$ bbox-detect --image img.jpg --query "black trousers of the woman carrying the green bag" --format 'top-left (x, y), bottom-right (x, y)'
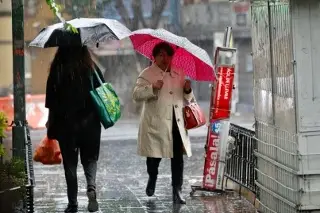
top-left (57, 113), bottom-right (101, 205)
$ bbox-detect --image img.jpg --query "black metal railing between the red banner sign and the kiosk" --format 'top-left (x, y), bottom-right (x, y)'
top-left (225, 124), bottom-right (257, 193)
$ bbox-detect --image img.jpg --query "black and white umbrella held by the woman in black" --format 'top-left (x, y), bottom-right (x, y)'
top-left (29, 18), bottom-right (131, 48)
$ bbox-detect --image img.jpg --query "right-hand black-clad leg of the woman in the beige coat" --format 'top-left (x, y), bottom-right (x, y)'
top-left (171, 117), bottom-right (185, 204)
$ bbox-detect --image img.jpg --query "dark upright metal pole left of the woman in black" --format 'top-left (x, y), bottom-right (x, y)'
top-left (12, 0), bottom-right (26, 159)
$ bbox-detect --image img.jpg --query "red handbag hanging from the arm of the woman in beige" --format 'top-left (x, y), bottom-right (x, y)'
top-left (183, 99), bottom-right (206, 130)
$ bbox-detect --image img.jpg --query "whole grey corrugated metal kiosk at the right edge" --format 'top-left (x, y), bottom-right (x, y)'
top-left (251, 0), bottom-right (320, 213)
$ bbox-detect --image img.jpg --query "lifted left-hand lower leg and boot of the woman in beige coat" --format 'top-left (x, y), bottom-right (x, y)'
top-left (146, 157), bottom-right (161, 197)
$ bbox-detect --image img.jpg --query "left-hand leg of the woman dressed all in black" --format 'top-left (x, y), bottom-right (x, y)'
top-left (59, 138), bottom-right (79, 212)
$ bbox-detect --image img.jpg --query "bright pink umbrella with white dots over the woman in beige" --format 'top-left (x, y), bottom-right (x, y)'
top-left (130, 29), bottom-right (215, 81)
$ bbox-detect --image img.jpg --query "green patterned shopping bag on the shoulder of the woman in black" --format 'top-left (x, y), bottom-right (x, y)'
top-left (90, 70), bottom-right (121, 129)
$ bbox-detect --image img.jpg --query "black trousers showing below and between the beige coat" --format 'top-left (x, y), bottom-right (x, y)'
top-left (147, 113), bottom-right (184, 189)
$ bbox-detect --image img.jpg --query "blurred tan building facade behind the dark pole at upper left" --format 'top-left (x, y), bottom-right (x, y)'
top-left (0, 0), bottom-right (59, 96)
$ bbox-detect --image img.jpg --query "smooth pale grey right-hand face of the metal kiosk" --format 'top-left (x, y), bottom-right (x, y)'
top-left (291, 0), bottom-right (320, 212)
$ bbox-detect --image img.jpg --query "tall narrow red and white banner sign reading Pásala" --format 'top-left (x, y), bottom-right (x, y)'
top-left (203, 65), bottom-right (234, 191)
